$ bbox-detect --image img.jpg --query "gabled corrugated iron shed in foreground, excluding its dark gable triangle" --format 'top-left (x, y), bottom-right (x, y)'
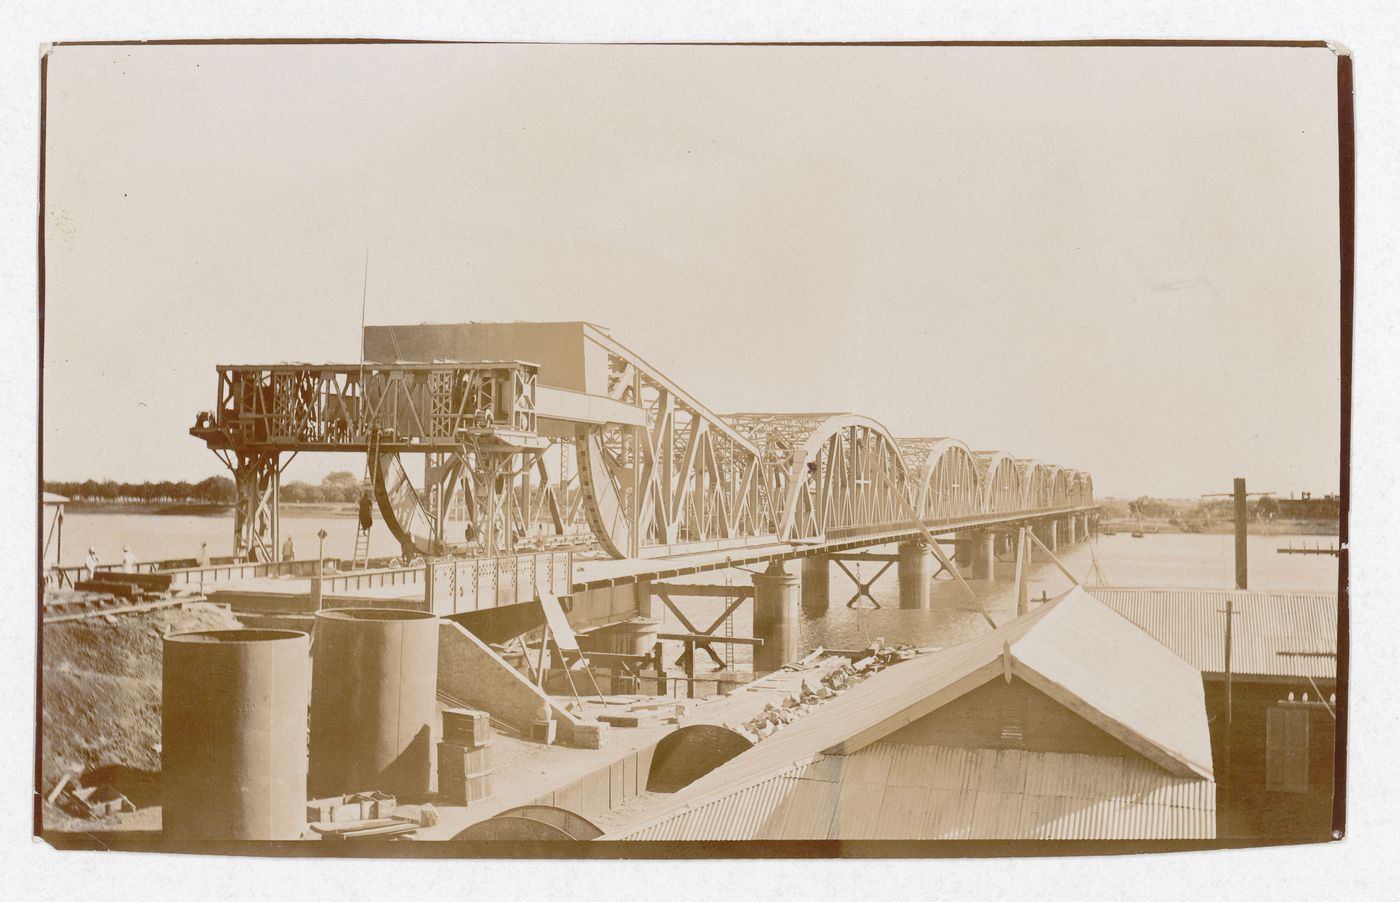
top-left (609, 590), bottom-right (1215, 839)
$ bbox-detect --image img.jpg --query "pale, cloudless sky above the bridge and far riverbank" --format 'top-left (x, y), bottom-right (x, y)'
top-left (42, 45), bottom-right (1340, 497)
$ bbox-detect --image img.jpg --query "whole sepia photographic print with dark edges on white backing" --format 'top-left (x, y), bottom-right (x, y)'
top-left (28, 35), bottom-right (1354, 859)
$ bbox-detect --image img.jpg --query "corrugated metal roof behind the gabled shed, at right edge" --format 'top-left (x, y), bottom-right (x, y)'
top-left (1088, 585), bottom-right (1337, 679)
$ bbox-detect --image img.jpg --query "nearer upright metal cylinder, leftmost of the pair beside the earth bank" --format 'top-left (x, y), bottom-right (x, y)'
top-left (161, 629), bottom-right (311, 842)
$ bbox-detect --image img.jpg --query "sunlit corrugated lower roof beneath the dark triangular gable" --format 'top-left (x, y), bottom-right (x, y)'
top-left (605, 742), bottom-right (1215, 840)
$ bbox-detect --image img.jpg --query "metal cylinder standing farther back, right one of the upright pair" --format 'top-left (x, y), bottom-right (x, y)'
top-left (311, 608), bottom-right (438, 798)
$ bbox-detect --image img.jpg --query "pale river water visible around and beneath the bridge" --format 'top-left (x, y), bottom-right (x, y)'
top-left (54, 513), bottom-right (1337, 669)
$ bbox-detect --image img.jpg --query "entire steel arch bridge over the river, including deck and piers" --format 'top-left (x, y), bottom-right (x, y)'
top-left (190, 322), bottom-right (1096, 672)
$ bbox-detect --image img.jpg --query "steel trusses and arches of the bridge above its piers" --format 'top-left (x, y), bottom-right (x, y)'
top-left (190, 322), bottom-right (1095, 560)
